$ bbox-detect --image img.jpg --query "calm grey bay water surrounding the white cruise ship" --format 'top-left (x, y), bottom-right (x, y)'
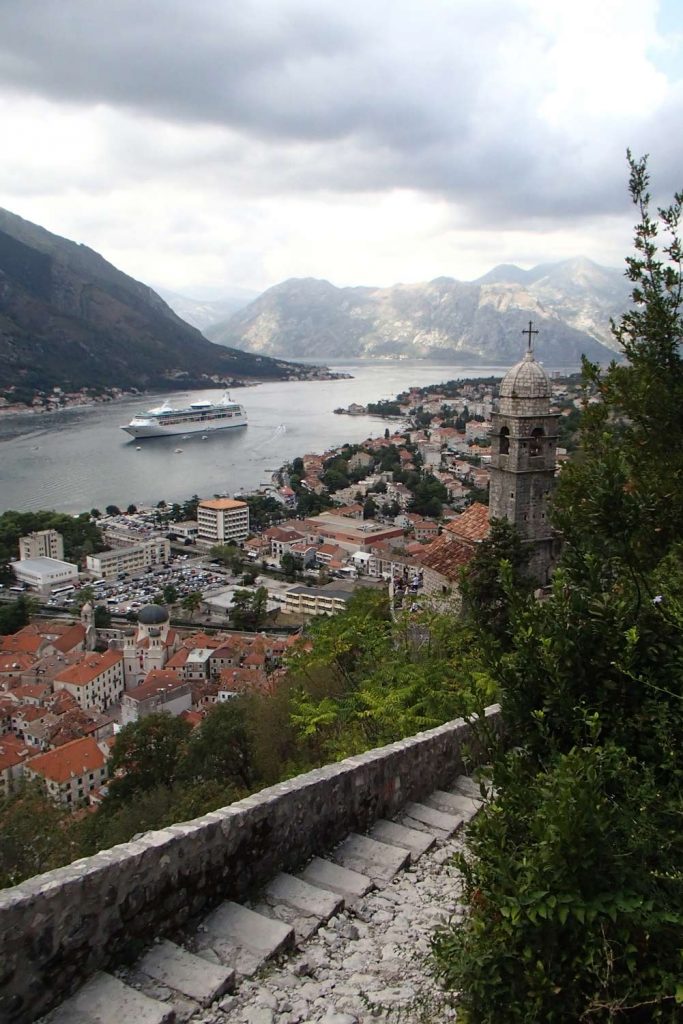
top-left (0, 361), bottom-right (518, 512)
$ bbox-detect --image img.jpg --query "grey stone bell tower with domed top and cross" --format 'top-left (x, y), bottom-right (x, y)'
top-left (488, 321), bottom-right (558, 585)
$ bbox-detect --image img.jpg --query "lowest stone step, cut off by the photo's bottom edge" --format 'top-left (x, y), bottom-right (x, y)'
top-left (43, 971), bottom-right (175, 1024)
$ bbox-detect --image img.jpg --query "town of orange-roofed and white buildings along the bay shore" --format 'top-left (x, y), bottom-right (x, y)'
top-left (0, 364), bottom-right (582, 807)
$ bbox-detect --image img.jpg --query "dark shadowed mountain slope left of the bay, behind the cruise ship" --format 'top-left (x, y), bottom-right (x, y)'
top-left (0, 209), bottom-right (300, 395)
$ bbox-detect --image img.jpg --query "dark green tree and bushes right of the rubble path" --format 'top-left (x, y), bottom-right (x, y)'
top-left (435, 155), bottom-right (683, 1024)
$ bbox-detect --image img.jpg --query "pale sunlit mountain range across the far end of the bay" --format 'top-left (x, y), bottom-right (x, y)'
top-left (206, 259), bottom-right (628, 367)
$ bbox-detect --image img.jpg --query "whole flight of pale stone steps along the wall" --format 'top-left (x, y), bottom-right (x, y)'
top-left (43, 776), bottom-right (481, 1024)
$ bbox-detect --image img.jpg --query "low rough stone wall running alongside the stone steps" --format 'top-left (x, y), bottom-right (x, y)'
top-left (0, 706), bottom-right (501, 1024)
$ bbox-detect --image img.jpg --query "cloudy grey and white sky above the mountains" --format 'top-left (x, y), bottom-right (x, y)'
top-left (0, 0), bottom-right (683, 298)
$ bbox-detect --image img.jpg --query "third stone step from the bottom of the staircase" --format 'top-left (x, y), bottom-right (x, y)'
top-left (195, 901), bottom-right (294, 975)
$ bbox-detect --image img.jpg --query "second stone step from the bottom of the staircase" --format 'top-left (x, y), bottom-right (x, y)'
top-left (135, 941), bottom-right (234, 1007)
